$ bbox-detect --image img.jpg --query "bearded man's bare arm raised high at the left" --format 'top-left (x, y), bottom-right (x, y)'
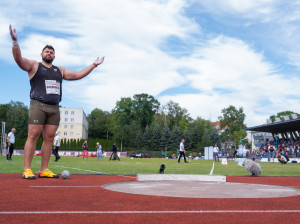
top-left (9, 25), bottom-right (35, 72)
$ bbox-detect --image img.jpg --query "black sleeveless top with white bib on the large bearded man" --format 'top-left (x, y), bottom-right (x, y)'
top-left (30, 63), bottom-right (62, 105)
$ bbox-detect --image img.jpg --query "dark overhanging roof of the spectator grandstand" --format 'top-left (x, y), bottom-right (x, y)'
top-left (245, 118), bottom-right (300, 133)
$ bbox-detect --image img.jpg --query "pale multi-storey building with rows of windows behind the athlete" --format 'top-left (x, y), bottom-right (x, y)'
top-left (57, 108), bottom-right (89, 139)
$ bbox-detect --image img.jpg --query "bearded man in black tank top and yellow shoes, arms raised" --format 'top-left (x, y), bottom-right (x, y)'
top-left (9, 25), bottom-right (104, 179)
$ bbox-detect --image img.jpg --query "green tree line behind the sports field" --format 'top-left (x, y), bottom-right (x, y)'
top-left (0, 93), bottom-right (255, 152)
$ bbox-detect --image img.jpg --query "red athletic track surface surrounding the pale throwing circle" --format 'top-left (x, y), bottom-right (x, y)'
top-left (0, 174), bottom-right (300, 224)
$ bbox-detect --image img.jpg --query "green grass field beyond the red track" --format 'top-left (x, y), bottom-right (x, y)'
top-left (0, 156), bottom-right (300, 176)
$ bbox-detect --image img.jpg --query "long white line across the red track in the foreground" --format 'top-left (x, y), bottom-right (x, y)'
top-left (0, 210), bottom-right (300, 215)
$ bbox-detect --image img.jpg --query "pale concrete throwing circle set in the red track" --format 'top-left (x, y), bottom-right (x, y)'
top-left (102, 181), bottom-right (300, 198)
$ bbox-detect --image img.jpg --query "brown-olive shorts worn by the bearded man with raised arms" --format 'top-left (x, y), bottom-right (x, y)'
top-left (28, 100), bottom-right (60, 126)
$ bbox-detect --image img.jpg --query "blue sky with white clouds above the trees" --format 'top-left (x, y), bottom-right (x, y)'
top-left (0, 0), bottom-right (300, 126)
